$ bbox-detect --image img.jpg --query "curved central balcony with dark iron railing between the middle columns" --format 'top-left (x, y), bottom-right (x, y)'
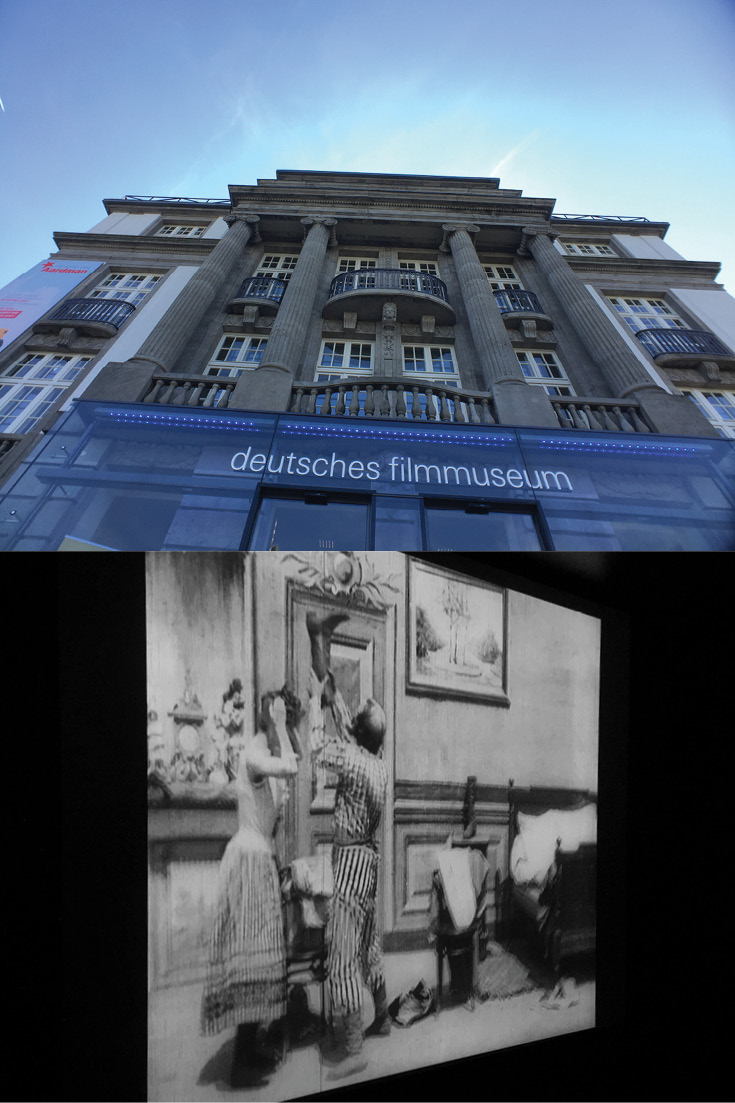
top-left (322, 268), bottom-right (456, 325)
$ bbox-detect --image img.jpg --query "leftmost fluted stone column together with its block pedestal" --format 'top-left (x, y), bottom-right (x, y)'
top-left (84, 214), bottom-right (260, 401)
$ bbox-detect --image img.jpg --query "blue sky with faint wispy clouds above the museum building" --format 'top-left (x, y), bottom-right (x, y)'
top-left (0, 0), bottom-right (735, 293)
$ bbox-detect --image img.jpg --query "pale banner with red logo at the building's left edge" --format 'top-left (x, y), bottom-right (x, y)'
top-left (0, 259), bottom-right (102, 349)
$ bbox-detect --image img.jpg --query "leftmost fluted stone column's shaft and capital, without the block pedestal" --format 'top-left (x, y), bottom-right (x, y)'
top-left (121, 214), bottom-right (259, 372)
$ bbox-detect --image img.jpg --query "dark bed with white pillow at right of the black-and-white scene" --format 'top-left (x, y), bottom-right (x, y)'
top-left (497, 780), bottom-right (597, 974)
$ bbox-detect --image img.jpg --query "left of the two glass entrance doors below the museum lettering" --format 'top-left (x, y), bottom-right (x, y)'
top-left (248, 493), bottom-right (371, 552)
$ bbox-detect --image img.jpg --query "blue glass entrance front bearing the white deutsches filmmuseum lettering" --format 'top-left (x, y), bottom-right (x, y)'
top-left (0, 400), bottom-right (735, 550)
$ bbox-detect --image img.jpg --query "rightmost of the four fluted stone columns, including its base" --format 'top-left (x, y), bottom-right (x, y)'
top-left (518, 226), bottom-right (716, 437)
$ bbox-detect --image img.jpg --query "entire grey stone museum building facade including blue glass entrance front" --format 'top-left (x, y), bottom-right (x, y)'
top-left (0, 171), bottom-right (735, 550)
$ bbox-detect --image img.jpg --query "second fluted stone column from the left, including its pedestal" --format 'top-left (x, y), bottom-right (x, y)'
top-left (230, 218), bottom-right (337, 410)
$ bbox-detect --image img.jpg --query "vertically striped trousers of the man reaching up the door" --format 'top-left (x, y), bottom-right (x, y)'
top-left (327, 846), bottom-right (385, 1013)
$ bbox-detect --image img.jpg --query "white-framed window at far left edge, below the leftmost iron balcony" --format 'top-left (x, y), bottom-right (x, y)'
top-left (0, 353), bottom-right (92, 433)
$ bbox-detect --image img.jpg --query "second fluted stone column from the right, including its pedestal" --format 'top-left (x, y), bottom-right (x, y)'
top-left (440, 225), bottom-right (558, 427)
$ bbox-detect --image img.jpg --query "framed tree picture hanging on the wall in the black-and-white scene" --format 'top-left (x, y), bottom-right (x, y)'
top-left (406, 559), bottom-right (510, 706)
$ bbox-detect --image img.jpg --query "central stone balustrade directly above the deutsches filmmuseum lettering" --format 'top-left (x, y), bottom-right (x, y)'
top-left (289, 378), bottom-right (498, 425)
